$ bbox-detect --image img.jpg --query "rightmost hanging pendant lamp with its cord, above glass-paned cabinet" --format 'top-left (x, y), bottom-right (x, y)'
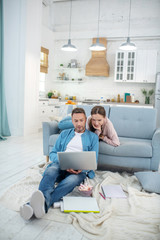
top-left (119, 0), bottom-right (136, 51)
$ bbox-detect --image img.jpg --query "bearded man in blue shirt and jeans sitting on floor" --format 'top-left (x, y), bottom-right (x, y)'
top-left (20, 108), bottom-right (99, 220)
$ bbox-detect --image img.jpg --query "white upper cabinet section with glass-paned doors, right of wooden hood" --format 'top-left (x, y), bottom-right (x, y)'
top-left (115, 51), bottom-right (136, 82)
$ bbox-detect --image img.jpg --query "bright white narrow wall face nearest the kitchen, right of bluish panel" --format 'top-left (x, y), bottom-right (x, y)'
top-left (24, 0), bottom-right (42, 135)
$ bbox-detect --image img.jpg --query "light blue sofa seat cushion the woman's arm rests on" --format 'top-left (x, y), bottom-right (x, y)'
top-left (99, 137), bottom-right (152, 158)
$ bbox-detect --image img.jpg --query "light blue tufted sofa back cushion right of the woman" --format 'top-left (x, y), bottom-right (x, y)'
top-left (109, 106), bottom-right (156, 139)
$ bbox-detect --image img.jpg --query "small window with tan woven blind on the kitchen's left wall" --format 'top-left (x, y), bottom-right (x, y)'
top-left (40, 47), bottom-right (49, 73)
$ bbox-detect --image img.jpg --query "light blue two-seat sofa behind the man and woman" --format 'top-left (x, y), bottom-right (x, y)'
top-left (43, 105), bottom-right (160, 171)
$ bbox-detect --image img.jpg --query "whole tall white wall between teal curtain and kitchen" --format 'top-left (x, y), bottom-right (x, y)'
top-left (3, 0), bottom-right (42, 135)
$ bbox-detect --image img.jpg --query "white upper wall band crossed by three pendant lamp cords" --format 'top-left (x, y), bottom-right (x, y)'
top-left (43, 0), bottom-right (160, 39)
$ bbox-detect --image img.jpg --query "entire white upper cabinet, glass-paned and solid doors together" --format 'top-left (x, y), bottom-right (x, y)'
top-left (115, 50), bottom-right (157, 83)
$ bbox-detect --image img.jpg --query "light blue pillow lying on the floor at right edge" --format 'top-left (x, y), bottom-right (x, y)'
top-left (134, 172), bottom-right (160, 193)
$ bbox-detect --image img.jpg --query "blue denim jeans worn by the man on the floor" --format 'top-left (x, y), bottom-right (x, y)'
top-left (39, 163), bottom-right (86, 212)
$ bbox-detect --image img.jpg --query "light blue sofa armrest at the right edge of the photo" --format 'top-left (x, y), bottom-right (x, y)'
top-left (151, 128), bottom-right (160, 171)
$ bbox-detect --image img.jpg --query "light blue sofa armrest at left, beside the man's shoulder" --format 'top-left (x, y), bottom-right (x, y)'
top-left (42, 121), bottom-right (59, 156)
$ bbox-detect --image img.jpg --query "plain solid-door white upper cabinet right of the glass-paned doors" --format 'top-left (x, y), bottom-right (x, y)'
top-left (136, 50), bottom-right (157, 83)
